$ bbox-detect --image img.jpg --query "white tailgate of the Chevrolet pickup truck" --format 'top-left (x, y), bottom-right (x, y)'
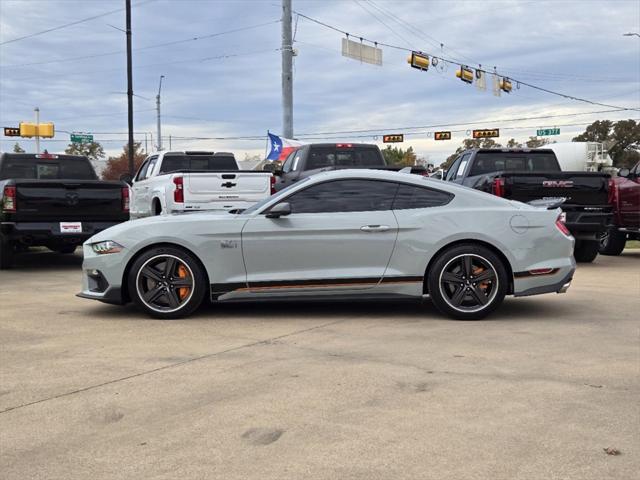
top-left (184, 171), bottom-right (271, 204)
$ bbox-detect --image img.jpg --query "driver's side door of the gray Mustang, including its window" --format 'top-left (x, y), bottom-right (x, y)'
top-left (242, 179), bottom-right (398, 292)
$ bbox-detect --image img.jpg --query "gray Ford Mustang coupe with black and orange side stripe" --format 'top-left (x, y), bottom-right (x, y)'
top-left (79, 170), bottom-right (575, 319)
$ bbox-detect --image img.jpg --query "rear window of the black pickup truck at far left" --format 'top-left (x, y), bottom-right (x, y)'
top-left (0, 155), bottom-right (96, 180)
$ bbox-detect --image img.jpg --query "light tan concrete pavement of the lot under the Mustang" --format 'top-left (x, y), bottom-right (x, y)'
top-left (0, 250), bottom-right (640, 480)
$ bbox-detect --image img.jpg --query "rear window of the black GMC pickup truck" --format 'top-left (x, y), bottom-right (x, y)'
top-left (469, 151), bottom-right (560, 176)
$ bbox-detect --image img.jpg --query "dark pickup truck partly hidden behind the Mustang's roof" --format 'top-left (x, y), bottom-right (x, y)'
top-left (273, 143), bottom-right (427, 191)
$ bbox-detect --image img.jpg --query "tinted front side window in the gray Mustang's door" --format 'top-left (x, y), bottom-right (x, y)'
top-left (284, 180), bottom-right (398, 214)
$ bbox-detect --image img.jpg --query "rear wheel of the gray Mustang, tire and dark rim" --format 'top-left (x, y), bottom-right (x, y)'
top-left (427, 243), bottom-right (509, 320)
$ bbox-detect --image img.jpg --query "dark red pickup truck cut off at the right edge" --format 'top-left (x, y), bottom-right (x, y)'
top-left (600, 162), bottom-right (640, 255)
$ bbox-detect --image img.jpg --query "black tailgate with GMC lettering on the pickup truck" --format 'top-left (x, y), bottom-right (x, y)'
top-left (500, 172), bottom-right (609, 205)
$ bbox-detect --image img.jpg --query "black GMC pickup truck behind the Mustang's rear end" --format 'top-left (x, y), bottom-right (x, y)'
top-left (445, 149), bottom-right (612, 262)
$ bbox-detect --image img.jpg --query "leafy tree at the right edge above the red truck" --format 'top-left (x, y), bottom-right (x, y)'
top-left (573, 119), bottom-right (640, 167)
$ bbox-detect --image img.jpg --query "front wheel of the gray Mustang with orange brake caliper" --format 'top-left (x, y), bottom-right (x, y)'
top-left (127, 247), bottom-right (209, 319)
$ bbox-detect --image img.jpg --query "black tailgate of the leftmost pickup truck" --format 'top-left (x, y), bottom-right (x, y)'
top-left (15, 180), bottom-right (128, 222)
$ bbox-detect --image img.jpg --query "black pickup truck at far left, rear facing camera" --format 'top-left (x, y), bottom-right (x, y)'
top-left (0, 153), bottom-right (129, 269)
